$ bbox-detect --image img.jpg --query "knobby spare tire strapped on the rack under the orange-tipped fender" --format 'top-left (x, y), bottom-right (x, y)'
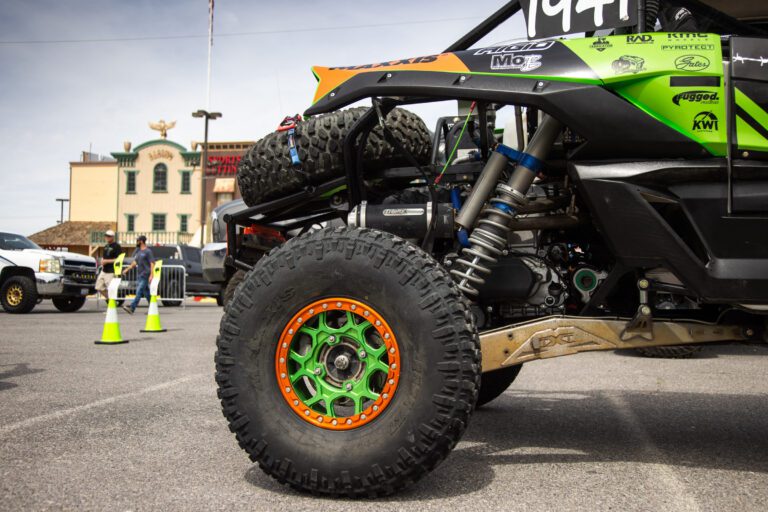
top-left (237, 107), bottom-right (432, 206)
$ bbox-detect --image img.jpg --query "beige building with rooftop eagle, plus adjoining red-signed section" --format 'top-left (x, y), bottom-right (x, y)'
top-left (61, 121), bottom-right (253, 252)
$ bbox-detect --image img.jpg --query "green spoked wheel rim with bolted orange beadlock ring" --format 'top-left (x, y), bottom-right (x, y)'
top-left (275, 297), bottom-right (400, 430)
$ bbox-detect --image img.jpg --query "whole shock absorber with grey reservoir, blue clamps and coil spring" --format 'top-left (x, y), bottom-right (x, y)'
top-left (451, 115), bottom-right (562, 296)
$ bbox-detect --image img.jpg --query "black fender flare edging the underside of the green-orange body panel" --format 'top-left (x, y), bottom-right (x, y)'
top-left (307, 71), bottom-right (704, 159)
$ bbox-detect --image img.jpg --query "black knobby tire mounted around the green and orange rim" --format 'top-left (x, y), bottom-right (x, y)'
top-left (215, 228), bottom-right (480, 497)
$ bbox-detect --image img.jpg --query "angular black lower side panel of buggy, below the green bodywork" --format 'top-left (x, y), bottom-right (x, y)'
top-left (570, 159), bottom-right (768, 304)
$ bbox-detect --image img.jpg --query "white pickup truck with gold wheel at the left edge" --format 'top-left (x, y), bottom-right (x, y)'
top-left (0, 233), bottom-right (96, 313)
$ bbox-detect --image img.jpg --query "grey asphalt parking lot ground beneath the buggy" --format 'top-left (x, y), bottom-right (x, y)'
top-left (0, 303), bottom-right (768, 511)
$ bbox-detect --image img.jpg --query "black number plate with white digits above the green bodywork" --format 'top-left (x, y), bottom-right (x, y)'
top-left (520, 0), bottom-right (637, 39)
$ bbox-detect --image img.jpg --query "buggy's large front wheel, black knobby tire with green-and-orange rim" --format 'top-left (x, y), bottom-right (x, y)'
top-left (215, 228), bottom-right (480, 497)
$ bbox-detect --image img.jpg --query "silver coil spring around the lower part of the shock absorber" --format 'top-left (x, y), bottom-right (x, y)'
top-left (451, 183), bottom-right (524, 296)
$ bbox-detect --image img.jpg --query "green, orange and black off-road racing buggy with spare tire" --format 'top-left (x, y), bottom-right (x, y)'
top-left (216, 0), bottom-right (768, 496)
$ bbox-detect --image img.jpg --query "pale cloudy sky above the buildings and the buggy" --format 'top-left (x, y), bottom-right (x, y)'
top-left (0, 0), bottom-right (523, 235)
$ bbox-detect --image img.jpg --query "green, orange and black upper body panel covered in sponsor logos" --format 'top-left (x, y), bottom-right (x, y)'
top-left (313, 32), bottom-right (768, 157)
